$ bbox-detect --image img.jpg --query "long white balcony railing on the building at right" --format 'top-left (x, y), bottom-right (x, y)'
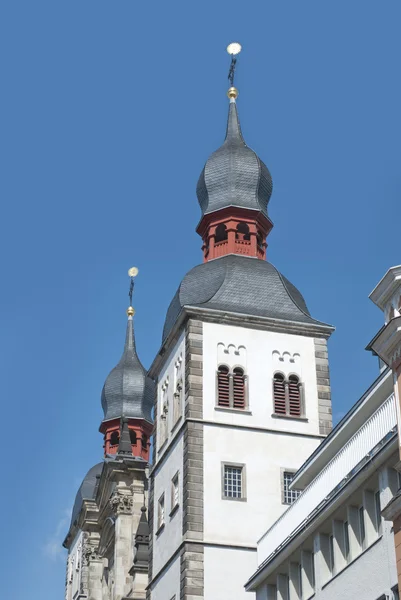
top-left (258, 394), bottom-right (397, 565)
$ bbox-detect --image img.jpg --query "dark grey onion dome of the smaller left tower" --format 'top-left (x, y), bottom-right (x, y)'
top-left (102, 317), bottom-right (154, 423)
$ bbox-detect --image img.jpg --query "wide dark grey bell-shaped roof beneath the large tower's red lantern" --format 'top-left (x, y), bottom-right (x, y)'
top-left (163, 254), bottom-right (325, 340)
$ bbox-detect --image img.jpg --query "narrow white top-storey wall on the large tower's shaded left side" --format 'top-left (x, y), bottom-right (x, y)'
top-left (157, 331), bottom-right (185, 458)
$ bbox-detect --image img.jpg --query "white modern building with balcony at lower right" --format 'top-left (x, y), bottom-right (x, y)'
top-left (247, 372), bottom-right (399, 600)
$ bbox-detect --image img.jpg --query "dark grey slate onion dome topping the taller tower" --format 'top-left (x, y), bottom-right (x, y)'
top-left (196, 100), bottom-right (273, 216)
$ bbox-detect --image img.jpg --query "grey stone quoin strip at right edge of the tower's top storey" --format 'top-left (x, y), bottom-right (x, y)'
top-left (314, 338), bottom-right (333, 435)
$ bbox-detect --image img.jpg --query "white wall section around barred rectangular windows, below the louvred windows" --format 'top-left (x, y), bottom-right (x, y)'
top-left (204, 425), bottom-right (320, 548)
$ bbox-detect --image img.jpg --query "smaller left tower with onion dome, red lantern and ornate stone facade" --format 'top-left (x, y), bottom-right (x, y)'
top-left (63, 278), bottom-right (154, 600)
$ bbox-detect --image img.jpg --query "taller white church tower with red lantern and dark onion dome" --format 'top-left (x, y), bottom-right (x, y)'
top-left (148, 47), bottom-right (333, 600)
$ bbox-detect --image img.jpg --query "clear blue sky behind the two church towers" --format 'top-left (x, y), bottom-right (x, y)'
top-left (0, 0), bottom-right (401, 600)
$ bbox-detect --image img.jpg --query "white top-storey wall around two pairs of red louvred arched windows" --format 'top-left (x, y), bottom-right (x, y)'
top-left (203, 323), bottom-right (319, 434)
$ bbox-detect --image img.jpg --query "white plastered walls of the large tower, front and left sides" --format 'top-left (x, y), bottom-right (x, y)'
top-left (150, 321), bottom-right (325, 600)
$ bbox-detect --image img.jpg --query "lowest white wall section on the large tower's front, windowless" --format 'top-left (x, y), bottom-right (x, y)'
top-left (204, 547), bottom-right (257, 600)
